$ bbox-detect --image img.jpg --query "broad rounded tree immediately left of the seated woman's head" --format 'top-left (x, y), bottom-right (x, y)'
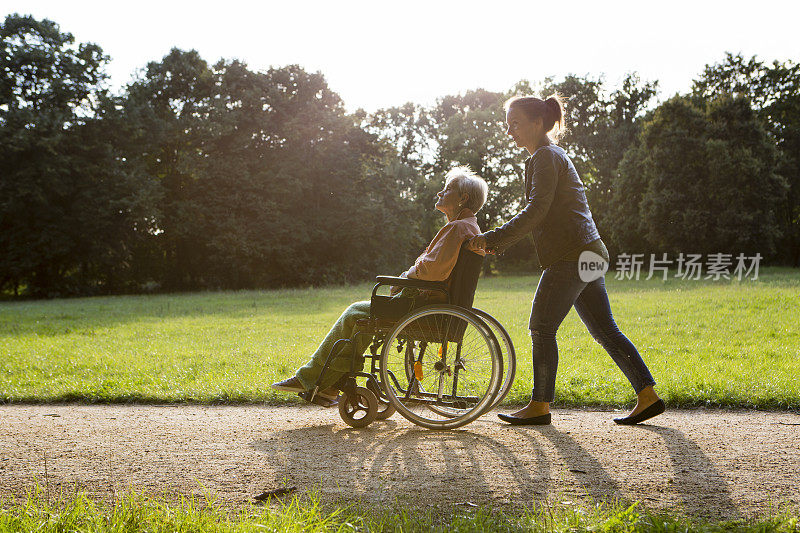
top-left (201, 62), bottom-right (415, 286)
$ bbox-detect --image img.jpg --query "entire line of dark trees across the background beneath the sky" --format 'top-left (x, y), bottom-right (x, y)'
top-left (0, 15), bottom-right (800, 297)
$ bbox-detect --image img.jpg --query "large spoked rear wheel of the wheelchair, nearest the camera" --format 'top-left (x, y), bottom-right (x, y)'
top-left (380, 305), bottom-right (502, 429)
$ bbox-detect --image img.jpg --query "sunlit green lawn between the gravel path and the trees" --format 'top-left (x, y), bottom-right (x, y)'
top-left (0, 269), bottom-right (800, 409)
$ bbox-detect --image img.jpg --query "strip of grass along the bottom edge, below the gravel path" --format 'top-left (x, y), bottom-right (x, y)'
top-left (0, 491), bottom-right (800, 533)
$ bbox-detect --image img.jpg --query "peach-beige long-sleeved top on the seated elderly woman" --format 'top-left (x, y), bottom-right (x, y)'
top-left (400, 208), bottom-right (484, 281)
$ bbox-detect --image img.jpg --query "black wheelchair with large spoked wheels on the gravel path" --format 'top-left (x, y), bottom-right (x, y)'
top-left (300, 243), bottom-right (516, 429)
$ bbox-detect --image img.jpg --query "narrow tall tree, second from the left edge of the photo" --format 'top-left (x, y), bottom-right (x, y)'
top-left (123, 48), bottom-right (214, 290)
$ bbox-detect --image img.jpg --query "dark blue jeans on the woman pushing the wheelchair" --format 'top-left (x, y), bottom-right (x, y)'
top-left (529, 261), bottom-right (655, 402)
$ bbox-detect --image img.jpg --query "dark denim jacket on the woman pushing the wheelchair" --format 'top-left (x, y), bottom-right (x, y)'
top-left (486, 144), bottom-right (600, 268)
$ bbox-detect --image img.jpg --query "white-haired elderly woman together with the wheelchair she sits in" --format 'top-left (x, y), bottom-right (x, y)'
top-left (272, 167), bottom-right (513, 428)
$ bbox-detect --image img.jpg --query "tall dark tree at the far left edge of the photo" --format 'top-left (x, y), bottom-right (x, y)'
top-left (0, 15), bottom-right (156, 296)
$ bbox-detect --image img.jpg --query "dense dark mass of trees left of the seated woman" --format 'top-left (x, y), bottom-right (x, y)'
top-left (0, 16), bottom-right (420, 296)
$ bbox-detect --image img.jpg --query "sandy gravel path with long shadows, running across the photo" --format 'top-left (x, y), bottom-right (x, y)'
top-left (0, 405), bottom-right (800, 518)
